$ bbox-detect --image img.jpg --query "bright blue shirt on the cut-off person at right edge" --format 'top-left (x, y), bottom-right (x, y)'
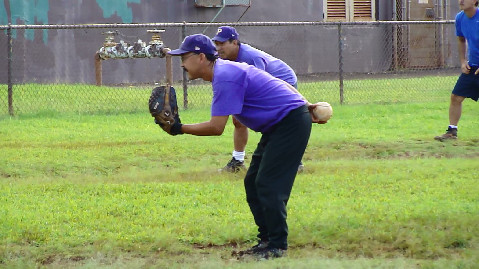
top-left (456, 8), bottom-right (479, 66)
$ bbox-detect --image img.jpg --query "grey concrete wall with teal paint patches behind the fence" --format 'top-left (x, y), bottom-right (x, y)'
top-left (0, 0), bottom-right (446, 84)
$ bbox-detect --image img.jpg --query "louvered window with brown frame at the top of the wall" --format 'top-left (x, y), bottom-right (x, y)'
top-left (323, 0), bottom-right (376, 21)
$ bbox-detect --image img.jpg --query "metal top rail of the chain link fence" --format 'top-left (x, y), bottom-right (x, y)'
top-left (0, 20), bottom-right (454, 30)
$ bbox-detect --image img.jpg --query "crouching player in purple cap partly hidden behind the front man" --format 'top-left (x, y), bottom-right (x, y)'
top-left (212, 26), bottom-right (304, 173)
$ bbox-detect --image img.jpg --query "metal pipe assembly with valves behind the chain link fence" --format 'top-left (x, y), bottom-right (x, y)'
top-left (95, 29), bottom-right (173, 86)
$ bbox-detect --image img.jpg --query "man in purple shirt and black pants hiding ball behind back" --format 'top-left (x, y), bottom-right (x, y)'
top-left (168, 34), bottom-right (326, 259)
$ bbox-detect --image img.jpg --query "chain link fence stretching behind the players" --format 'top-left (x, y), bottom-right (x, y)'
top-left (0, 21), bottom-right (460, 115)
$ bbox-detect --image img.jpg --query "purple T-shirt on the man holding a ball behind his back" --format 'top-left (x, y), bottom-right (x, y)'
top-left (211, 59), bottom-right (306, 133)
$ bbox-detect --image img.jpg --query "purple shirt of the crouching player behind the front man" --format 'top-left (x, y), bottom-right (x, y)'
top-left (236, 44), bottom-right (298, 85)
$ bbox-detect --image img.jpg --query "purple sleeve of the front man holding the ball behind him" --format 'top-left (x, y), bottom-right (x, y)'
top-left (211, 81), bottom-right (245, 116)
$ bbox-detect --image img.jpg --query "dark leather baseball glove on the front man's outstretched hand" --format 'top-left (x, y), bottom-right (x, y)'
top-left (148, 85), bottom-right (183, 135)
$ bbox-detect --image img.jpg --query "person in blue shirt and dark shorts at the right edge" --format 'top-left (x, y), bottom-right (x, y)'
top-left (434, 0), bottom-right (479, 142)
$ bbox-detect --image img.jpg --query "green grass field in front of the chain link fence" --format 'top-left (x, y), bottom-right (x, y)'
top-left (0, 85), bottom-right (479, 268)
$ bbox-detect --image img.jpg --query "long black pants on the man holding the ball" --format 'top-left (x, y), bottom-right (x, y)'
top-left (244, 106), bottom-right (312, 249)
